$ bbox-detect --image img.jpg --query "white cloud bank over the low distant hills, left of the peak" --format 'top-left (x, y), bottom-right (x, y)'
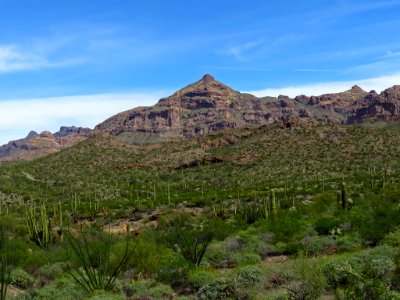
top-left (0, 91), bottom-right (165, 145)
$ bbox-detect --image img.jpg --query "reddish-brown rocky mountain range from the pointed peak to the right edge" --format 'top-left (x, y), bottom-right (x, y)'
top-left (94, 75), bottom-right (400, 144)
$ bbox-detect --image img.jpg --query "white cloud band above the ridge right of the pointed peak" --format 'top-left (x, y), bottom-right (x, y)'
top-left (246, 73), bottom-right (400, 97)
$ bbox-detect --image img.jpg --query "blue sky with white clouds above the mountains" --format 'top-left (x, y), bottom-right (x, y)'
top-left (0, 0), bottom-right (400, 144)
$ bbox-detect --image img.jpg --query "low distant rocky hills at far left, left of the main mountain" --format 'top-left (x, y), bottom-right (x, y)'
top-left (0, 126), bottom-right (91, 161)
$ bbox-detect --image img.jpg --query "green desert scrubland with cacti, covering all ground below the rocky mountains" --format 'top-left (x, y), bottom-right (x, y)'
top-left (0, 123), bottom-right (400, 299)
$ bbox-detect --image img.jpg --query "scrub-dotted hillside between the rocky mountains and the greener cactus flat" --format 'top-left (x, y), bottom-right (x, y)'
top-left (0, 122), bottom-right (400, 207)
